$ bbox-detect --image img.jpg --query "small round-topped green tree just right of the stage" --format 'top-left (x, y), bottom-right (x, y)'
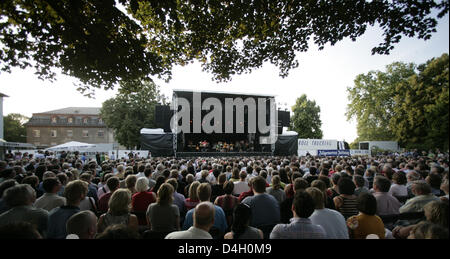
top-left (290, 94), bottom-right (323, 139)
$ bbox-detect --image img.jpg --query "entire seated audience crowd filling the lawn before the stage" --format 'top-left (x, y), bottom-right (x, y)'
top-left (0, 152), bottom-right (449, 239)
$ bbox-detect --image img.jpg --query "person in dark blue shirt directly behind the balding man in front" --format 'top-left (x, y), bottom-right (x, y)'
top-left (183, 183), bottom-right (228, 235)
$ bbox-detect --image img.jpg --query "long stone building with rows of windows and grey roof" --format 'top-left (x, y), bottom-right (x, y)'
top-left (25, 107), bottom-right (117, 148)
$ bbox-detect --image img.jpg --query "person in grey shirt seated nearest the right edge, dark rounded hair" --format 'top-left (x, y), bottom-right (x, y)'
top-left (399, 180), bottom-right (439, 213)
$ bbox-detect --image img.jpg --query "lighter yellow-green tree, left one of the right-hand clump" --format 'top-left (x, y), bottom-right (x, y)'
top-left (346, 62), bottom-right (415, 141)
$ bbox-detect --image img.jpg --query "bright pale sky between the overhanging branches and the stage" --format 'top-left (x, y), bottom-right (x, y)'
top-left (0, 14), bottom-right (449, 143)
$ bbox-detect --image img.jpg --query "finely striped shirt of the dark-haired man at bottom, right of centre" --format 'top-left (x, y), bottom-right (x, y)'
top-left (270, 218), bottom-right (327, 239)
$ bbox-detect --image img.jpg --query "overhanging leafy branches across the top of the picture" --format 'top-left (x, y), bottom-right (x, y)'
top-left (0, 0), bottom-right (449, 94)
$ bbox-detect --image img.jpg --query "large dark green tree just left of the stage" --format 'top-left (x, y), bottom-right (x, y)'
top-left (100, 81), bottom-right (166, 149)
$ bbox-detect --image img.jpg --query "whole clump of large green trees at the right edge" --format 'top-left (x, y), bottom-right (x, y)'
top-left (347, 53), bottom-right (449, 150)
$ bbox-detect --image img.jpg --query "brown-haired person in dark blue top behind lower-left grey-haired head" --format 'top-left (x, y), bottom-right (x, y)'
top-left (47, 180), bottom-right (88, 239)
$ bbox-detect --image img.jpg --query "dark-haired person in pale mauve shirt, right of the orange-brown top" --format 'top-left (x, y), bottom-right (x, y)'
top-left (373, 176), bottom-right (402, 216)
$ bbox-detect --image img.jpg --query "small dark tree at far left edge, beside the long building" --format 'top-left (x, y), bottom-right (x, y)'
top-left (3, 113), bottom-right (30, 143)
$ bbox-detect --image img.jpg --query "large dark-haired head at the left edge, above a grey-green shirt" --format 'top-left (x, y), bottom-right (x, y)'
top-left (3, 184), bottom-right (36, 208)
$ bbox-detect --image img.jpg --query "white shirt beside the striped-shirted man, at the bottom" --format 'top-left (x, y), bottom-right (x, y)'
top-left (309, 208), bottom-right (349, 239)
